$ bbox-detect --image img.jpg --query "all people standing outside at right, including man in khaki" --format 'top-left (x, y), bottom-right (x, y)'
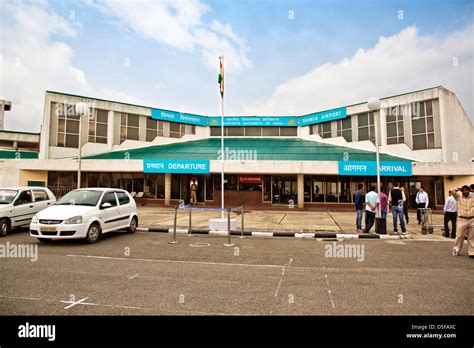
top-left (354, 183), bottom-right (474, 258)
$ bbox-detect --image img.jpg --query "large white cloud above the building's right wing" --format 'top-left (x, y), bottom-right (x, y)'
top-left (244, 25), bottom-right (474, 119)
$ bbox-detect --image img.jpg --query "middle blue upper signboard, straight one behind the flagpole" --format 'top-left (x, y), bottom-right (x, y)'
top-left (209, 116), bottom-right (298, 127)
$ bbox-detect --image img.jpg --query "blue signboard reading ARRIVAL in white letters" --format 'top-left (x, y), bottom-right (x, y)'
top-left (338, 161), bottom-right (411, 176)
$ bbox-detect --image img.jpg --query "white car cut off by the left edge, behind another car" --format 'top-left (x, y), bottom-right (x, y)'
top-left (0, 187), bottom-right (56, 237)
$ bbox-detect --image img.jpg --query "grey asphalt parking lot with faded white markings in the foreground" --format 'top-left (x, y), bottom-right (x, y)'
top-left (0, 230), bottom-right (474, 315)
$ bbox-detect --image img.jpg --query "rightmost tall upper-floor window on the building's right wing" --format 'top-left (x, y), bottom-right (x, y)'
top-left (411, 100), bottom-right (435, 150)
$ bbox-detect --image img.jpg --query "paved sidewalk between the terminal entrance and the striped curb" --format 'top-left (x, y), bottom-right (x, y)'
top-left (138, 207), bottom-right (452, 239)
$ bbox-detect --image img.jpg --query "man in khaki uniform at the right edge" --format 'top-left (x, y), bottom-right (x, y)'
top-left (453, 185), bottom-right (474, 258)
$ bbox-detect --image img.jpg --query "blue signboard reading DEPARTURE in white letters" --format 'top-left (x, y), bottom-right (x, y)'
top-left (143, 160), bottom-right (210, 174)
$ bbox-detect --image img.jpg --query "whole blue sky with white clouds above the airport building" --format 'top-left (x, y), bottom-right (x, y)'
top-left (0, 0), bottom-right (474, 132)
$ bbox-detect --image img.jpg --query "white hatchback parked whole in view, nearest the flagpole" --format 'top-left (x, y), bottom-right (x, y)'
top-left (30, 188), bottom-right (138, 243)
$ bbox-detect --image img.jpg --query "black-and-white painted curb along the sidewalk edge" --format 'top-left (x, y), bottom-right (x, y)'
top-left (137, 227), bottom-right (408, 239)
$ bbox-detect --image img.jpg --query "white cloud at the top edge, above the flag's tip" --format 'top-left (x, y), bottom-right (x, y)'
top-left (88, 0), bottom-right (251, 73)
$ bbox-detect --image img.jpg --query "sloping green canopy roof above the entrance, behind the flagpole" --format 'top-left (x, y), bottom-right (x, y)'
top-left (84, 138), bottom-right (411, 161)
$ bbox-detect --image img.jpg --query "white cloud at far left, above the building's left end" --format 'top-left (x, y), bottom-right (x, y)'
top-left (0, 2), bottom-right (148, 132)
